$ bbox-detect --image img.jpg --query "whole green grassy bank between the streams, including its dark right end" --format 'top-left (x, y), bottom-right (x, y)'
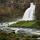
top-left (9, 20), bottom-right (40, 29)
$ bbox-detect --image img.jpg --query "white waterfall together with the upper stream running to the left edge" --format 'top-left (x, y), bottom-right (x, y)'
top-left (0, 3), bottom-right (35, 27)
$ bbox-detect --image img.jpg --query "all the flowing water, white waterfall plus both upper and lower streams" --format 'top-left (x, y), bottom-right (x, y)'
top-left (0, 3), bottom-right (40, 40)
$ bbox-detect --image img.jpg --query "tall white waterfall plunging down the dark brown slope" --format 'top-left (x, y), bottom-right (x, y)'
top-left (22, 3), bottom-right (35, 21)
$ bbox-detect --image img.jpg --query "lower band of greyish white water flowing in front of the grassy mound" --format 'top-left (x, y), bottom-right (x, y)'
top-left (0, 27), bottom-right (40, 35)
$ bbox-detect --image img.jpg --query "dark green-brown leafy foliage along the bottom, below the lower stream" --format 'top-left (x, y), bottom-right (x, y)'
top-left (0, 32), bottom-right (38, 40)
